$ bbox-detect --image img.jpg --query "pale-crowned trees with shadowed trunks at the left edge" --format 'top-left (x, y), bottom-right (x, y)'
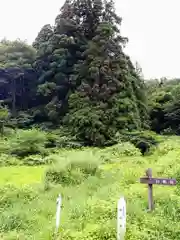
top-left (0, 39), bottom-right (37, 117)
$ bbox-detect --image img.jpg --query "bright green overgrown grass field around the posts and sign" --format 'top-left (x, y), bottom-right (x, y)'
top-left (0, 137), bottom-right (180, 240)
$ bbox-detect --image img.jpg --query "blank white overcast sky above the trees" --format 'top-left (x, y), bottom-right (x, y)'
top-left (0, 0), bottom-right (180, 78)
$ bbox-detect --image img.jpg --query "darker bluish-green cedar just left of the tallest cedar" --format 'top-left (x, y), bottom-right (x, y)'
top-left (34, 7), bottom-right (84, 122)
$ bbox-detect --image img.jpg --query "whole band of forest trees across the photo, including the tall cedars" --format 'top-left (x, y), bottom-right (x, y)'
top-left (0, 0), bottom-right (180, 146)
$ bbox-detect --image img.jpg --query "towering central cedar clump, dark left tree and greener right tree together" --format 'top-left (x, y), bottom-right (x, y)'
top-left (34, 0), bottom-right (147, 145)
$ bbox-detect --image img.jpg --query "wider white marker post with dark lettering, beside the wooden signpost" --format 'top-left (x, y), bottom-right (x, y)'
top-left (117, 197), bottom-right (126, 240)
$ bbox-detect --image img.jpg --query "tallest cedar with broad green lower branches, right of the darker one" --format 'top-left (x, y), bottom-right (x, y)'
top-left (64, 0), bottom-right (147, 145)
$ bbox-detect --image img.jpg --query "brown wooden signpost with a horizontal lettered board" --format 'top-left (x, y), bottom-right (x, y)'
top-left (140, 168), bottom-right (176, 211)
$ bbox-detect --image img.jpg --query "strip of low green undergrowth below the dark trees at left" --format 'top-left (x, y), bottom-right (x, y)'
top-left (0, 128), bottom-right (82, 166)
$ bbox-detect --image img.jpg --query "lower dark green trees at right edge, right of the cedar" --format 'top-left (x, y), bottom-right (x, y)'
top-left (148, 79), bottom-right (180, 135)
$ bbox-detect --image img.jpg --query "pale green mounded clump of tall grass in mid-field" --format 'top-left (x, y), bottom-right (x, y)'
top-left (45, 159), bottom-right (99, 185)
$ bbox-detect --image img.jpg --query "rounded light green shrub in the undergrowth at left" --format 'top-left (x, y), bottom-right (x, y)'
top-left (10, 129), bottom-right (47, 157)
